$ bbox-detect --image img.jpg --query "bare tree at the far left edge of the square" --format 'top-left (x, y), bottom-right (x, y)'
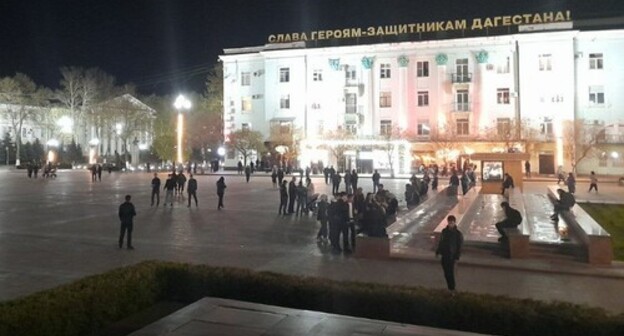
top-left (0, 73), bottom-right (47, 166)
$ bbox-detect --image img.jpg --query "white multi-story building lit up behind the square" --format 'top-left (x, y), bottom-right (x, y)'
top-left (221, 20), bottom-right (624, 174)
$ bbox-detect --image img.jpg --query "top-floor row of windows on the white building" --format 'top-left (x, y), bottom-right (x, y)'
top-left (236, 53), bottom-right (604, 86)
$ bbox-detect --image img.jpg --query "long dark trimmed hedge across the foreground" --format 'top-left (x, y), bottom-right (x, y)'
top-left (0, 261), bottom-right (624, 335)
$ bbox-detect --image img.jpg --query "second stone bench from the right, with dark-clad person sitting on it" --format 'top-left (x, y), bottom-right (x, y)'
top-left (503, 188), bottom-right (531, 259)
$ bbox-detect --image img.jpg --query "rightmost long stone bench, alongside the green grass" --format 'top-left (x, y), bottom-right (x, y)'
top-left (548, 186), bottom-right (613, 265)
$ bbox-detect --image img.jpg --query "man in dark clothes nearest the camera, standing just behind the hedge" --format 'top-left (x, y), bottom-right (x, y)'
top-left (436, 215), bottom-right (464, 292)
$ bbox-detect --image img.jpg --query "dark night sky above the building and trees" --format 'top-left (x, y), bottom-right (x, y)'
top-left (0, 0), bottom-right (624, 94)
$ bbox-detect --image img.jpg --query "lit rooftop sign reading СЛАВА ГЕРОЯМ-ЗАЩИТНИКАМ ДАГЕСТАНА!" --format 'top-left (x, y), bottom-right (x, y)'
top-left (268, 10), bottom-right (572, 43)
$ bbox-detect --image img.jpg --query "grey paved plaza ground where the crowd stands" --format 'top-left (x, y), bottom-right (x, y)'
top-left (0, 169), bottom-right (624, 313)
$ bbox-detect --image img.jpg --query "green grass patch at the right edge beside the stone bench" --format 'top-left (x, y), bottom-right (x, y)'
top-left (579, 203), bottom-right (624, 261)
